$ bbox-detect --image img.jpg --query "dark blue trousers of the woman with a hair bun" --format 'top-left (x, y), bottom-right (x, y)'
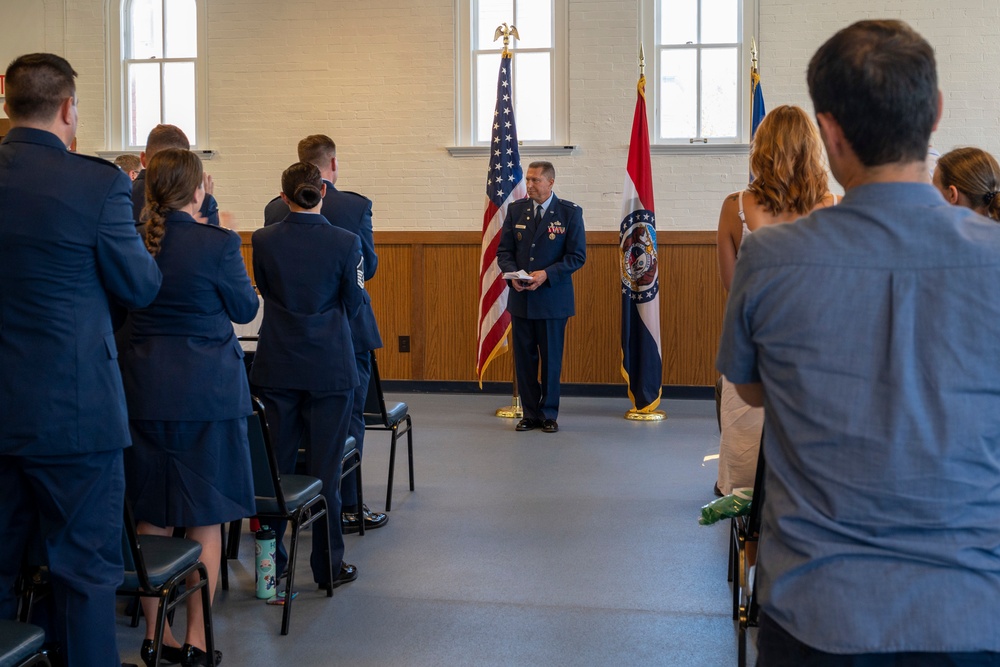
top-left (258, 387), bottom-right (354, 584)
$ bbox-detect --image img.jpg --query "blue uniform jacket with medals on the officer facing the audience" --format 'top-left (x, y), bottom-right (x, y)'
top-left (497, 195), bottom-right (587, 320)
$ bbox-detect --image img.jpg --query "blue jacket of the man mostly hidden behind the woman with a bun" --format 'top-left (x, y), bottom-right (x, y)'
top-left (264, 181), bottom-right (382, 352)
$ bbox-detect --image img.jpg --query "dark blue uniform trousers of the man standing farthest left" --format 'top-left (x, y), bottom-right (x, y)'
top-left (0, 449), bottom-right (125, 667)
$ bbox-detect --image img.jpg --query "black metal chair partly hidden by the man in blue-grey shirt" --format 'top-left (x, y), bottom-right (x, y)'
top-left (729, 433), bottom-right (765, 667)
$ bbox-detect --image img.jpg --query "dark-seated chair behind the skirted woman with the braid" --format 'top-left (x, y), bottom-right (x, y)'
top-left (118, 501), bottom-right (215, 663)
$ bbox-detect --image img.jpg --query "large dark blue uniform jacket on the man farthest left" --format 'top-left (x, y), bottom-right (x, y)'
top-left (0, 127), bottom-right (161, 455)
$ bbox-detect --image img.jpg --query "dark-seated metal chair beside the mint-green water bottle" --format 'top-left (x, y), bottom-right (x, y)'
top-left (247, 396), bottom-right (339, 635)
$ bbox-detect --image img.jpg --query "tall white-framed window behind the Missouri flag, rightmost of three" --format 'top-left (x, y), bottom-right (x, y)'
top-left (644, 0), bottom-right (756, 145)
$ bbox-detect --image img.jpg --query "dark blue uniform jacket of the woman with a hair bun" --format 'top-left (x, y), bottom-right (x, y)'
top-left (250, 213), bottom-right (365, 392)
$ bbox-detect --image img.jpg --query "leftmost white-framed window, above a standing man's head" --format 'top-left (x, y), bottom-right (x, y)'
top-left (108, 0), bottom-right (207, 150)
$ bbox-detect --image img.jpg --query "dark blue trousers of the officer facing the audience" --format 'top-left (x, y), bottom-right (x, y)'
top-left (510, 317), bottom-right (566, 421)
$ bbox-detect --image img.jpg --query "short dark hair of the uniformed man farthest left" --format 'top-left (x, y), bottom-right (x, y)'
top-left (4, 53), bottom-right (76, 121)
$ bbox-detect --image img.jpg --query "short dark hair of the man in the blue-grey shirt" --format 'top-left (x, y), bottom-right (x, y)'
top-left (807, 21), bottom-right (938, 167)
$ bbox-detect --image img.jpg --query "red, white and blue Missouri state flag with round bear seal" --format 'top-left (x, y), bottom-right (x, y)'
top-left (619, 76), bottom-right (663, 413)
